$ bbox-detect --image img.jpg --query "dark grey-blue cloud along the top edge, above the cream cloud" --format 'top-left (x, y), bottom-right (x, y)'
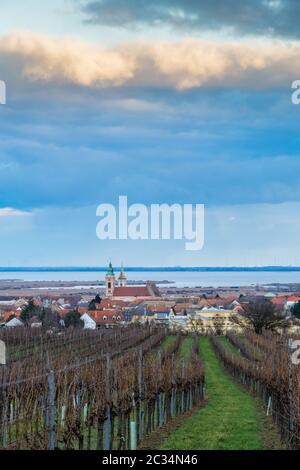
top-left (81, 0), bottom-right (300, 38)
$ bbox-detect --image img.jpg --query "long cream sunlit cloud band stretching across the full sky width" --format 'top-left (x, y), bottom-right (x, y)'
top-left (0, 33), bottom-right (300, 90)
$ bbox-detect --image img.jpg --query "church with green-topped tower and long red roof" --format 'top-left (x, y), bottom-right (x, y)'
top-left (105, 262), bottom-right (160, 302)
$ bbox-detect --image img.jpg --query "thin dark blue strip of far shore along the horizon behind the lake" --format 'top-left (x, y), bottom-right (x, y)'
top-left (0, 266), bottom-right (300, 273)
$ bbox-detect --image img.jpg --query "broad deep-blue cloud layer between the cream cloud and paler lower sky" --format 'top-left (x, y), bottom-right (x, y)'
top-left (0, 83), bottom-right (300, 211)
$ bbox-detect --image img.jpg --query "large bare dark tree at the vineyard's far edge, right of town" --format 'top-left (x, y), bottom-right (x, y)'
top-left (232, 299), bottom-right (290, 335)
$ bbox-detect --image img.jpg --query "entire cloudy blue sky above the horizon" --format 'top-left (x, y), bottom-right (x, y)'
top-left (0, 0), bottom-right (300, 266)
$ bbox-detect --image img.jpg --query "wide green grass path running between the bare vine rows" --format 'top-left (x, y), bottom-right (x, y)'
top-left (161, 337), bottom-right (280, 450)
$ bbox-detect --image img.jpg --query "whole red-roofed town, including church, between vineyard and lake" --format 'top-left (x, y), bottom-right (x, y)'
top-left (0, 262), bottom-right (300, 334)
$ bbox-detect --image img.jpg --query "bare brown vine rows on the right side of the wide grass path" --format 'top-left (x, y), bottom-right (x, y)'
top-left (212, 331), bottom-right (300, 449)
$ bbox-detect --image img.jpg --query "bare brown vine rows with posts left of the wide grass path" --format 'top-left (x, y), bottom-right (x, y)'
top-left (0, 325), bottom-right (204, 450)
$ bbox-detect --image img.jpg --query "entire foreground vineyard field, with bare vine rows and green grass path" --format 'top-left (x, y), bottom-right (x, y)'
top-left (0, 325), bottom-right (300, 450)
